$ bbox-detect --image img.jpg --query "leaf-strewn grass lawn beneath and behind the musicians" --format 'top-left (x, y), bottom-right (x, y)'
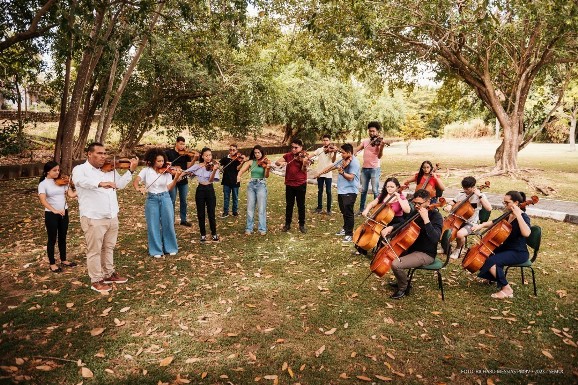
top-left (0, 141), bottom-right (578, 385)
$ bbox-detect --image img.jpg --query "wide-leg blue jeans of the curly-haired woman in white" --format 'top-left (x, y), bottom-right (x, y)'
top-left (145, 192), bottom-right (179, 255)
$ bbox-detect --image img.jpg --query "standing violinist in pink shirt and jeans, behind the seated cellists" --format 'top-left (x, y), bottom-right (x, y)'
top-left (355, 121), bottom-right (385, 215)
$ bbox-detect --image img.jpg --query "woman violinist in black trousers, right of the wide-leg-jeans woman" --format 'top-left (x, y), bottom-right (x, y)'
top-left (186, 147), bottom-right (220, 242)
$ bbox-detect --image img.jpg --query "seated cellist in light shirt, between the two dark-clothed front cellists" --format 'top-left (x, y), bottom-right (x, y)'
top-left (445, 176), bottom-right (492, 259)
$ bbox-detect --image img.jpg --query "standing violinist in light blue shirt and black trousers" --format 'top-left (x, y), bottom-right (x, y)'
top-left (318, 143), bottom-right (360, 243)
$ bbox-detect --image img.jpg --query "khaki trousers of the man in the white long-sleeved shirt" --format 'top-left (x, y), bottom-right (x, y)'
top-left (80, 217), bottom-right (118, 283)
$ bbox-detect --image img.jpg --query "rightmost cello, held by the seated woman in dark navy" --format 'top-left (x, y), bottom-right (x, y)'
top-left (462, 195), bottom-right (539, 273)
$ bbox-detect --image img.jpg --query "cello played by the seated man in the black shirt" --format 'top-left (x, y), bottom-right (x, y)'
top-left (370, 198), bottom-right (446, 277)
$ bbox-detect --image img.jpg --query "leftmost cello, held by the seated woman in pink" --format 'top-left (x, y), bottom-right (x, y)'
top-left (353, 185), bottom-right (408, 251)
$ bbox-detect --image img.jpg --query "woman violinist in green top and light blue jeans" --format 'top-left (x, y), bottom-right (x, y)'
top-left (237, 145), bottom-right (271, 235)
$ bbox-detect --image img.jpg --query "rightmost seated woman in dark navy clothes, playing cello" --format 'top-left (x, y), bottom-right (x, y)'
top-left (472, 191), bottom-right (531, 299)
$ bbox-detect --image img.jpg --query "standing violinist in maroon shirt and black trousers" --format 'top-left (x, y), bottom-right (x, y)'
top-left (275, 139), bottom-right (309, 233)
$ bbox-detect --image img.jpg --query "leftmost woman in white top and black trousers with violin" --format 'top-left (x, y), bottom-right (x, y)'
top-left (38, 161), bottom-right (76, 273)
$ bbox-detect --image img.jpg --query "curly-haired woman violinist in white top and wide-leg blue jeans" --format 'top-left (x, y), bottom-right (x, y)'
top-left (133, 148), bottom-right (182, 258)
